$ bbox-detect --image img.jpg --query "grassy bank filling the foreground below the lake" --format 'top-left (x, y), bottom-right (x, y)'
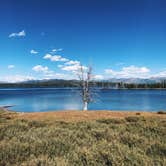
top-left (0, 111), bottom-right (166, 166)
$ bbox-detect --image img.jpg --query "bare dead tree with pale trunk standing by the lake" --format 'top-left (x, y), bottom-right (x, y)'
top-left (78, 65), bottom-right (92, 111)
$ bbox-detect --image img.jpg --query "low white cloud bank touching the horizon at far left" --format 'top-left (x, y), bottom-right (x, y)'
top-left (0, 75), bottom-right (35, 83)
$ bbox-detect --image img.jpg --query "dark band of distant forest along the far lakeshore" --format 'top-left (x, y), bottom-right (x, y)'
top-left (0, 80), bottom-right (166, 89)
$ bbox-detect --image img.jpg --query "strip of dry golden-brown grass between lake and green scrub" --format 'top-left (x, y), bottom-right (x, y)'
top-left (16, 110), bottom-right (166, 122)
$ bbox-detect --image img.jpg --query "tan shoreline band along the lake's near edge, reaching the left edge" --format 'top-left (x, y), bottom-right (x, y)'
top-left (0, 108), bottom-right (166, 122)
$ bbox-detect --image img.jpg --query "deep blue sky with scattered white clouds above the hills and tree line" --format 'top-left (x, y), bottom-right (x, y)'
top-left (0, 0), bottom-right (166, 82)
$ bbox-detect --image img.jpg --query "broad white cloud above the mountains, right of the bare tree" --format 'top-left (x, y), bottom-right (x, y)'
top-left (105, 65), bottom-right (150, 78)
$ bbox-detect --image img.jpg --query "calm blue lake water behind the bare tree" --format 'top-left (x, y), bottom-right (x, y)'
top-left (0, 88), bottom-right (166, 112)
